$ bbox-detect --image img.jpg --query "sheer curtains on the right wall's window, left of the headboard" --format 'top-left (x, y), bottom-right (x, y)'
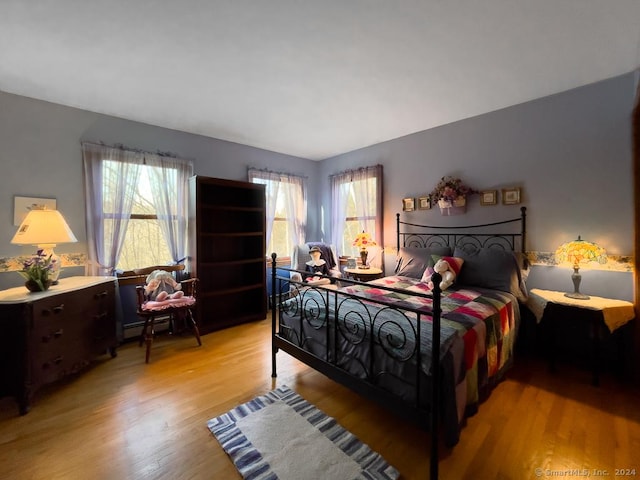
top-left (330, 165), bottom-right (384, 267)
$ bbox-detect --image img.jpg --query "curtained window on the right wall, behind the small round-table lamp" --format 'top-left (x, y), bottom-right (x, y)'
top-left (331, 165), bottom-right (382, 265)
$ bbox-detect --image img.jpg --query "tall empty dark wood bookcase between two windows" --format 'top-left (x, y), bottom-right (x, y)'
top-left (189, 176), bottom-right (267, 333)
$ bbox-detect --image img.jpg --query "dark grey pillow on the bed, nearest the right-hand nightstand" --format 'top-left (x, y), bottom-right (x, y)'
top-left (454, 248), bottom-right (528, 301)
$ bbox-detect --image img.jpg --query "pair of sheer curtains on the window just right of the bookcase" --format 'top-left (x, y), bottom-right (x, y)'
top-left (247, 168), bottom-right (307, 253)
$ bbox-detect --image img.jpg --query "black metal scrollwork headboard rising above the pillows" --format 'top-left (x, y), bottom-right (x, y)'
top-left (396, 207), bottom-right (527, 253)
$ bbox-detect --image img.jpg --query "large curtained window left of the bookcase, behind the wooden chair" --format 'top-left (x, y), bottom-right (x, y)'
top-left (82, 143), bottom-right (193, 275)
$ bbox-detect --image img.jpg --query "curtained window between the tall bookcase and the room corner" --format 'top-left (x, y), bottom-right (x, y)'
top-left (248, 169), bottom-right (307, 257)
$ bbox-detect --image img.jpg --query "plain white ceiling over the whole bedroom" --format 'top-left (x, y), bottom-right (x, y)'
top-left (0, 0), bottom-right (640, 160)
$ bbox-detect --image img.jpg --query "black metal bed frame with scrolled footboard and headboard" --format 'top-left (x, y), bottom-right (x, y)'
top-left (271, 207), bottom-right (526, 479)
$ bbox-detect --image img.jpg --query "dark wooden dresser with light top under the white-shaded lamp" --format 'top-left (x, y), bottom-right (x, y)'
top-left (0, 276), bottom-right (118, 415)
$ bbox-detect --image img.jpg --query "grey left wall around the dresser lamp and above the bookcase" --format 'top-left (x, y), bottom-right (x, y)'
top-left (0, 92), bottom-right (319, 289)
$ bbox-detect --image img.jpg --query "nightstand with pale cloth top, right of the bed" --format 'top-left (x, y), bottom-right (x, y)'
top-left (527, 288), bottom-right (635, 385)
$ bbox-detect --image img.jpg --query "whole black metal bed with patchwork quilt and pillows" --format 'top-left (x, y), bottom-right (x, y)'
top-left (271, 207), bottom-right (528, 478)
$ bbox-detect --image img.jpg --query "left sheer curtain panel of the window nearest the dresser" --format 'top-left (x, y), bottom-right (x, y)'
top-left (82, 143), bottom-right (144, 275)
